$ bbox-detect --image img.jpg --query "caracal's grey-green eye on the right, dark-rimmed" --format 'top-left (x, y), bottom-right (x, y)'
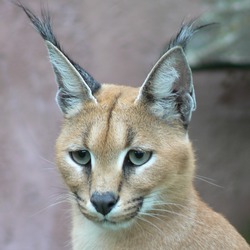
top-left (126, 149), bottom-right (152, 166)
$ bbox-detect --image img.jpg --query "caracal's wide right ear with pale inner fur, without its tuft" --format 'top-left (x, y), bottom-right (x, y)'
top-left (136, 46), bottom-right (196, 128)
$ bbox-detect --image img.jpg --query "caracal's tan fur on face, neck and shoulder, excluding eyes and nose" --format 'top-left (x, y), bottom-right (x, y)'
top-left (56, 84), bottom-right (249, 250)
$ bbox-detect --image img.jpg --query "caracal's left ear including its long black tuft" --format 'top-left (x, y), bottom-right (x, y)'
top-left (16, 1), bottom-right (101, 116)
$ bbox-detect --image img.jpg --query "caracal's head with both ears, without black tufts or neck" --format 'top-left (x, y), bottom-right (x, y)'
top-left (52, 44), bottom-right (195, 228)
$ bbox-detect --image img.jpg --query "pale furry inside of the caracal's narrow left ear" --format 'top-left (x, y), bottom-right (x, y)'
top-left (46, 41), bottom-right (97, 116)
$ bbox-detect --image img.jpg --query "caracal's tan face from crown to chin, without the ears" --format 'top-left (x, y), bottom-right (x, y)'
top-left (56, 85), bottom-right (191, 228)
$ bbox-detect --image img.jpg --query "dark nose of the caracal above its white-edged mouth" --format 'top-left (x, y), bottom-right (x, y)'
top-left (90, 192), bottom-right (118, 215)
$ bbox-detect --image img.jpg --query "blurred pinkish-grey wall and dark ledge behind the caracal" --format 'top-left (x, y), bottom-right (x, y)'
top-left (0, 0), bottom-right (250, 250)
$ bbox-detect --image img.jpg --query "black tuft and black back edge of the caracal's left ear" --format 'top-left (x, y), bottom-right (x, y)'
top-left (14, 1), bottom-right (101, 94)
